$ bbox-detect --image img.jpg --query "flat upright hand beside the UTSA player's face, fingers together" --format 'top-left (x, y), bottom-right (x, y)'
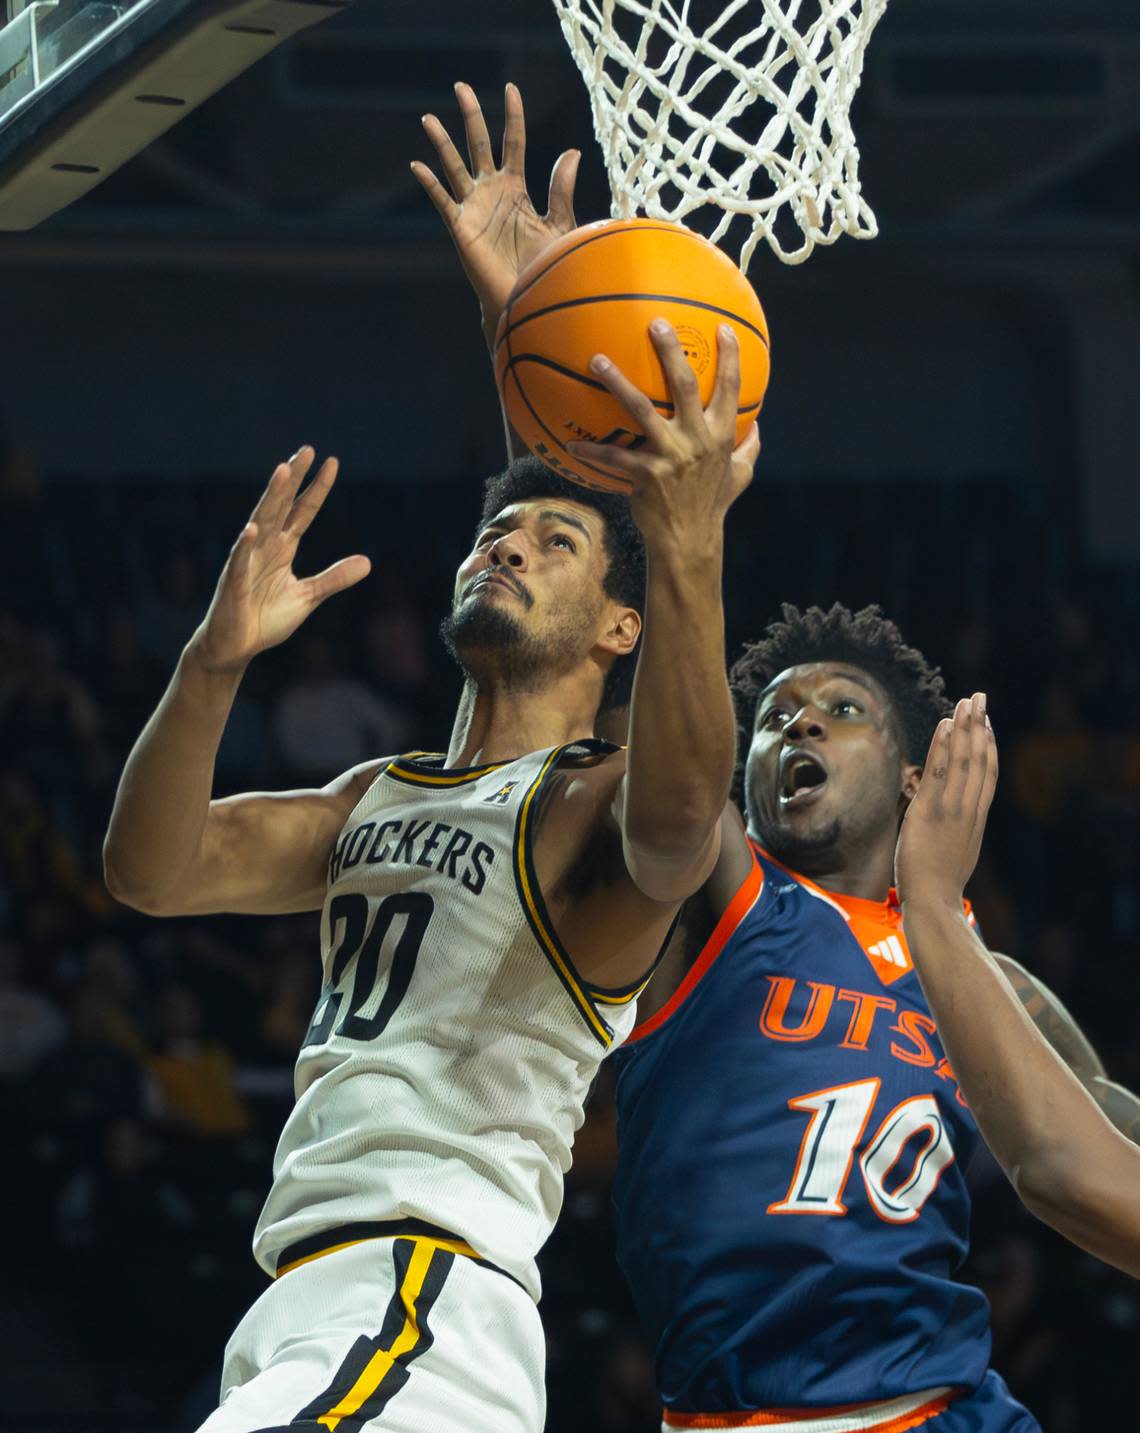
top-left (895, 692), bottom-right (998, 907)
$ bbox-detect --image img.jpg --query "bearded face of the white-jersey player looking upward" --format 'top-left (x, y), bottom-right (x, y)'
top-left (444, 499), bottom-right (614, 684)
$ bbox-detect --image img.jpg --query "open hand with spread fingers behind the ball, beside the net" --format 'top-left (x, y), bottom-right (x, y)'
top-left (411, 85), bottom-right (581, 338)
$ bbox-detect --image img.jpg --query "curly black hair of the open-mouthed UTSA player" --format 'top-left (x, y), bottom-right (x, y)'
top-left (729, 602), bottom-right (952, 765)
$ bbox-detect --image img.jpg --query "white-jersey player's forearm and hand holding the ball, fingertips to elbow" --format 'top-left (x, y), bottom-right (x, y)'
top-left (570, 321), bottom-right (759, 903)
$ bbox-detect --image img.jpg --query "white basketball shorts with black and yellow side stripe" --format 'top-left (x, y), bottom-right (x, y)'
top-left (199, 1234), bottom-right (546, 1433)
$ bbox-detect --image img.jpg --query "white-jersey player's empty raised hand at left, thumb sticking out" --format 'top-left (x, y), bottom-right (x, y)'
top-left (192, 447), bottom-right (372, 672)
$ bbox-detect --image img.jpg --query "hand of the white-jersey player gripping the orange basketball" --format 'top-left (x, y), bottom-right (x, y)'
top-left (567, 318), bottom-right (760, 553)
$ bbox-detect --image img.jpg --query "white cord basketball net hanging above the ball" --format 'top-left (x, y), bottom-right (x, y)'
top-left (554, 0), bottom-right (887, 271)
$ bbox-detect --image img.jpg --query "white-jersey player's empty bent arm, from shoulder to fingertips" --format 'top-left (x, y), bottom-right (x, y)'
top-left (103, 447), bottom-right (380, 916)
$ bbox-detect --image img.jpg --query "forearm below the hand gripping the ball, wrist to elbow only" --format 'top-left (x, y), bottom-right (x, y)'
top-left (622, 533), bottom-right (736, 900)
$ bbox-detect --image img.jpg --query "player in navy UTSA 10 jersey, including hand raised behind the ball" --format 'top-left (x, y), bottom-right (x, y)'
top-left (417, 86), bottom-right (1140, 1433)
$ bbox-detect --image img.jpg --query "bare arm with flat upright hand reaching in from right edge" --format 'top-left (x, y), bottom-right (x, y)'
top-left (895, 694), bottom-right (1140, 1278)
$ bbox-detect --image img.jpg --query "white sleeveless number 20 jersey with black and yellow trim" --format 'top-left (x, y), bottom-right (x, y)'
top-left (253, 742), bottom-right (636, 1298)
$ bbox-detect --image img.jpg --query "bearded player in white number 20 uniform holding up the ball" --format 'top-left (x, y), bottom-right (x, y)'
top-left (106, 325), bottom-right (758, 1433)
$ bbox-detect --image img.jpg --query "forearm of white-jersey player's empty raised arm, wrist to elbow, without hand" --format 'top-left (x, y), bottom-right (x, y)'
top-left (103, 641), bottom-right (242, 913)
